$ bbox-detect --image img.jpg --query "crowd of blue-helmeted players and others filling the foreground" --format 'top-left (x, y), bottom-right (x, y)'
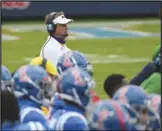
top-left (1, 46), bottom-right (161, 131)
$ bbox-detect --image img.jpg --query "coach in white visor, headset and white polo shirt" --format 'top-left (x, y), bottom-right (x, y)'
top-left (40, 11), bottom-right (73, 67)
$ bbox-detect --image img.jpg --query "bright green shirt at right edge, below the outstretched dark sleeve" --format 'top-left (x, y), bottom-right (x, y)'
top-left (141, 73), bottom-right (161, 94)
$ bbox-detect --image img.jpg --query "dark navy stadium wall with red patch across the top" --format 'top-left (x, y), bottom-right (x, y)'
top-left (2, 1), bottom-right (160, 20)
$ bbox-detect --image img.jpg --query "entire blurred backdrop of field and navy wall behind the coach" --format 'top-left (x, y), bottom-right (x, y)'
top-left (2, 1), bottom-right (161, 98)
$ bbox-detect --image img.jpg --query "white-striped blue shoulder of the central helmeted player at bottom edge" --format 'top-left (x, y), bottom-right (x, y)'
top-left (49, 110), bottom-right (89, 131)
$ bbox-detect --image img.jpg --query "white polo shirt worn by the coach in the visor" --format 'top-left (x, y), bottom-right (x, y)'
top-left (40, 36), bottom-right (71, 67)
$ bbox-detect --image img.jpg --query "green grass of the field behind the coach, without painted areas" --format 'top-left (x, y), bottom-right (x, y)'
top-left (2, 20), bottom-right (160, 98)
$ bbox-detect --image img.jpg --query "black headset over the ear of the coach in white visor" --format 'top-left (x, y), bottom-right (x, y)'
top-left (46, 12), bottom-right (56, 35)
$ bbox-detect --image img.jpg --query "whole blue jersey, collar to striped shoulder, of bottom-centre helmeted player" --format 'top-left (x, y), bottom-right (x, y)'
top-left (49, 99), bottom-right (88, 130)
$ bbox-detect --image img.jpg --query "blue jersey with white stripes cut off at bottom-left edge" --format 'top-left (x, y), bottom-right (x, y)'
top-left (2, 121), bottom-right (48, 131)
